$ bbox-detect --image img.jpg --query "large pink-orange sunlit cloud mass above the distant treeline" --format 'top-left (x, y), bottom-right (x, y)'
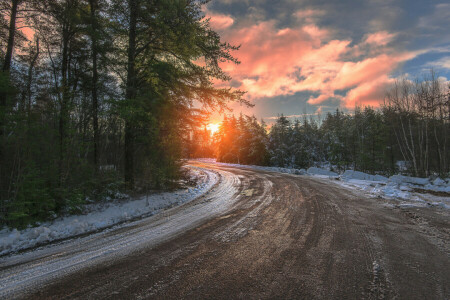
top-left (214, 16), bottom-right (416, 107)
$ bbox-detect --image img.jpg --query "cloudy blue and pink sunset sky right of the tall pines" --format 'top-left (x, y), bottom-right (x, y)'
top-left (203, 0), bottom-right (450, 123)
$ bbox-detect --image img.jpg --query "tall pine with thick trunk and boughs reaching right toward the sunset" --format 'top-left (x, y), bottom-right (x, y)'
top-left (113, 0), bottom-right (248, 186)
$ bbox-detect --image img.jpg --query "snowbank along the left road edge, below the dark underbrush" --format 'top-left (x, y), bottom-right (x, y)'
top-left (0, 166), bottom-right (218, 255)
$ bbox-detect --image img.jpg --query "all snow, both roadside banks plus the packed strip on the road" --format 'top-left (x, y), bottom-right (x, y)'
top-left (0, 160), bottom-right (450, 299)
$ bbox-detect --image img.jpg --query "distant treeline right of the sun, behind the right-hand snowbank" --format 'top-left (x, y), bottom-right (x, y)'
top-left (196, 72), bottom-right (450, 177)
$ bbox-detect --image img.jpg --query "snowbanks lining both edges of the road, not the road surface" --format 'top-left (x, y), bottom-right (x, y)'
top-left (0, 159), bottom-right (444, 255)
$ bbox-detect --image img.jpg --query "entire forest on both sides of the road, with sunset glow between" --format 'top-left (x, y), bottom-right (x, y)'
top-left (0, 0), bottom-right (450, 228)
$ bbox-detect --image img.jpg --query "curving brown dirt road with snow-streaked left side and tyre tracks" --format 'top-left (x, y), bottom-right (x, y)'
top-left (0, 162), bottom-right (450, 299)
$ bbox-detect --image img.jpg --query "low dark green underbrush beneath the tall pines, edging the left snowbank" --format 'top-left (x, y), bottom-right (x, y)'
top-left (0, 168), bottom-right (201, 230)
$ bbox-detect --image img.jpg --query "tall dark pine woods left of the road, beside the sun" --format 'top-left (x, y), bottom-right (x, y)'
top-left (0, 0), bottom-right (248, 226)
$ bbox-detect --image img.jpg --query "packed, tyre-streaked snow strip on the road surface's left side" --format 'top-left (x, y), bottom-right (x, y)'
top-left (0, 166), bottom-right (243, 299)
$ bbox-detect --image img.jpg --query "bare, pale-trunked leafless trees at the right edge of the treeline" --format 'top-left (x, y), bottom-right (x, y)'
top-left (383, 71), bottom-right (449, 176)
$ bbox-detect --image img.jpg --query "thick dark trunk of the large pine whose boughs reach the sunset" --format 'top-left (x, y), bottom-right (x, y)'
top-left (124, 0), bottom-right (138, 188)
